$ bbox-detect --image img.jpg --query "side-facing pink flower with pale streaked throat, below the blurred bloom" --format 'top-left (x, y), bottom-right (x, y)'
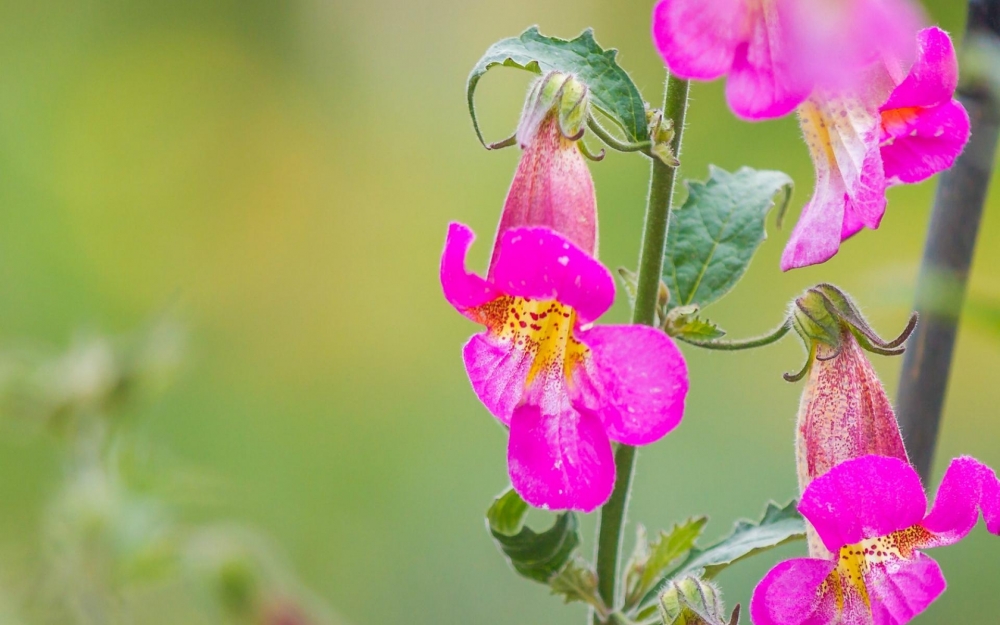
top-left (781, 28), bottom-right (969, 271)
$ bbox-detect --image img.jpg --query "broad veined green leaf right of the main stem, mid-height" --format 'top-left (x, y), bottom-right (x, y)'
top-left (663, 166), bottom-right (792, 308)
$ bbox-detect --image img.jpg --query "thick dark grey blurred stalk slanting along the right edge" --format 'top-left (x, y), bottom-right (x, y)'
top-left (897, 0), bottom-right (1000, 483)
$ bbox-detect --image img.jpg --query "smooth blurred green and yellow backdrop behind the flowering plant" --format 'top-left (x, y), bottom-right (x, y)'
top-left (0, 0), bottom-right (1000, 625)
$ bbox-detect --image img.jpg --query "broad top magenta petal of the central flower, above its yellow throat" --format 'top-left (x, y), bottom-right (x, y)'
top-left (493, 228), bottom-right (615, 324)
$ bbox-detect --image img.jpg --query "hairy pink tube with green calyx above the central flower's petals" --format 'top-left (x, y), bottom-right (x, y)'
top-left (489, 72), bottom-right (597, 276)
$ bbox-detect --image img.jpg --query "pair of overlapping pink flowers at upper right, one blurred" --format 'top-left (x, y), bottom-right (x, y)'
top-left (653, 0), bottom-right (969, 270)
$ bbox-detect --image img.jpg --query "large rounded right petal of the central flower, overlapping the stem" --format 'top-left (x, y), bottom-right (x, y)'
top-left (578, 326), bottom-right (688, 445)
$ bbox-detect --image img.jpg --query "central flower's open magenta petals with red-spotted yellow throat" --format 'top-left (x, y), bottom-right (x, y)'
top-left (441, 223), bottom-right (688, 511)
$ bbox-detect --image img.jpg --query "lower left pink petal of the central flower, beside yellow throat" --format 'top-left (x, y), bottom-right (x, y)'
top-left (462, 332), bottom-right (534, 426)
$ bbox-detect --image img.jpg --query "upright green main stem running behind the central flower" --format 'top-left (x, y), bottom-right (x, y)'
top-left (594, 75), bottom-right (688, 623)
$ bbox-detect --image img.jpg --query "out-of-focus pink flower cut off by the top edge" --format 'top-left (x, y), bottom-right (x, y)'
top-left (653, 0), bottom-right (921, 119)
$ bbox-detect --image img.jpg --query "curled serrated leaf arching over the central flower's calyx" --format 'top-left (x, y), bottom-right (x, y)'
top-left (466, 26), bottom-right (649, 145)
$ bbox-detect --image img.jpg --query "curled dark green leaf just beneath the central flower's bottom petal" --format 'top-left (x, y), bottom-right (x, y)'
top-left (486, 489), bottom-right (580, 584)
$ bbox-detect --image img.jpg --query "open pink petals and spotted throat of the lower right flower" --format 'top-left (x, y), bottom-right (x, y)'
top-left (750, 456), bottom-right (1000, 625)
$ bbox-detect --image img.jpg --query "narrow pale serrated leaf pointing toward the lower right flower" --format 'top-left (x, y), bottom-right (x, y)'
top-left (640, 500), bottom-right (806, 605)
